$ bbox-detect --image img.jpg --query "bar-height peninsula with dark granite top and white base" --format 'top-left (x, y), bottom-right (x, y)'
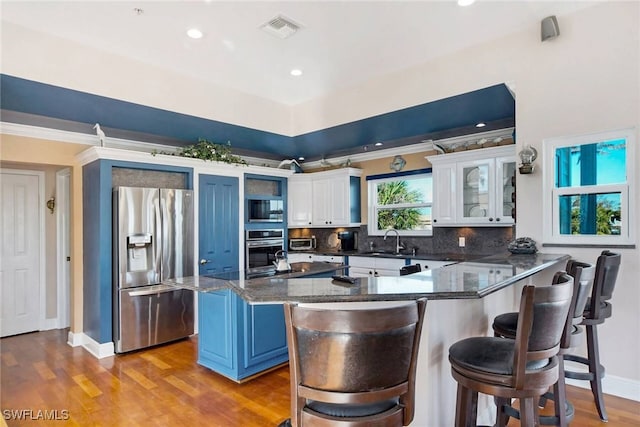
top-left (170, 253), bottom-right (569, 427)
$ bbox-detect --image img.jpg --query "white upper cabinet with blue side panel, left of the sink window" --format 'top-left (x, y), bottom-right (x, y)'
top-left (287, 168), bottom-right (362, 228)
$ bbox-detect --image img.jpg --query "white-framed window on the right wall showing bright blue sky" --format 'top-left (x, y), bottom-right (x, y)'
top-left (544, 130), bottom-right (635, 245)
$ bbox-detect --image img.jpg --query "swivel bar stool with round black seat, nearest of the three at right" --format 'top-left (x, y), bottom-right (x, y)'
top-left (449, 272), bottom-right (573, 427)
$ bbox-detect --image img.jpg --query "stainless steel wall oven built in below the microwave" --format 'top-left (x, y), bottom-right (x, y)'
top-left (245, 228), bottom-right (285, 273)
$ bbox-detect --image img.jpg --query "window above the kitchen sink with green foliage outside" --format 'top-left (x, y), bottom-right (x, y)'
top-left (367, 169), bottom-right (433, 236)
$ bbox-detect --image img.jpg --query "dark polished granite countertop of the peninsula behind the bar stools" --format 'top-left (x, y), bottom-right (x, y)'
top-left (163, 252), bottom-right (569, 303)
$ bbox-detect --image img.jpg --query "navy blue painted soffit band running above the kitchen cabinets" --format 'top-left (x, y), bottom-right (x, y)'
top-left (0, 74), bottom-right (515, 158)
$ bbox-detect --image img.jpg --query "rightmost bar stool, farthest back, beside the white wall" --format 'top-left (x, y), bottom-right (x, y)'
top-left (564, 250), bottom-right (621, 421)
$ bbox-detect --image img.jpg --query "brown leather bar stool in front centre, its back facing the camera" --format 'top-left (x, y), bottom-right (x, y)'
top-left (280, 299), bottom-right (426, 427)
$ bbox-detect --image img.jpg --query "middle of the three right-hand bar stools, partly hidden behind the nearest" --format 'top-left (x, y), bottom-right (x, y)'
top-left (493, 260), bottom-right (596, 427)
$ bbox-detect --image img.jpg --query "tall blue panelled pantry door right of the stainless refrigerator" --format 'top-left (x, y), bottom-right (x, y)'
top-left (198, 175), bottom-right (240, 275)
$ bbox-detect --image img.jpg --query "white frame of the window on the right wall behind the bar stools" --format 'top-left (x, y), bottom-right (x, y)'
top-left (542, 128), bottom-right (637, 247)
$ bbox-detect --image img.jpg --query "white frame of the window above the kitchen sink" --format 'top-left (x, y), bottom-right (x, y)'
top-left (366, 168), bottom-right (433, 237)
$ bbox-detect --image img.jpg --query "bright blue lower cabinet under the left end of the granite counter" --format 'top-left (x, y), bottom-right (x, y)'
top-left (198, 290), bottom-right (289, 381)
